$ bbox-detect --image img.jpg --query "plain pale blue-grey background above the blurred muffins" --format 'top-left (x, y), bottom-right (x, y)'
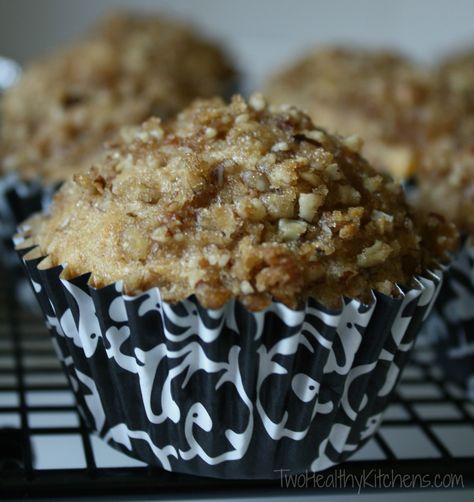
top-left (0, 0), bottom-right (474, 88)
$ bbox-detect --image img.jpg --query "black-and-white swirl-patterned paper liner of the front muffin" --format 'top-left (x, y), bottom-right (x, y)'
top-left (17, 235), bottom-right (444, 478)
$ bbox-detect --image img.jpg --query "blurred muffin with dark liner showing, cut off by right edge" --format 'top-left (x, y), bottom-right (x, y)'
top-left (415, 106), bottom-right (474, 400)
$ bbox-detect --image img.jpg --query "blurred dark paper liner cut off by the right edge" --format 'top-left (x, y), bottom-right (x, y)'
top-left (423, 237), bottom-right (474, 400)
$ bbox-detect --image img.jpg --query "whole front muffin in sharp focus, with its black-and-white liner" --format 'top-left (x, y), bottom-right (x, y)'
top-left (16, 94), bottom-right (456, 478)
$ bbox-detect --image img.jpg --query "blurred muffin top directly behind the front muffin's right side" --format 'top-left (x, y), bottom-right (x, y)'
top-left (267, 48), bottom-right (461, 178)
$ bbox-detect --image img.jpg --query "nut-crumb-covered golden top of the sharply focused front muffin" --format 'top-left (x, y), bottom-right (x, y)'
top-left (28, 94), bottom-right (456, 310)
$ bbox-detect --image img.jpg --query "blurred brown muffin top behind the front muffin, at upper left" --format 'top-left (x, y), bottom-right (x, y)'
top-left (0, 14), bottom-right (234, 182)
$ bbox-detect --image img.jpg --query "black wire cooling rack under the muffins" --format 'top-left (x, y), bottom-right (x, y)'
top-left (0, 264), bottom-right (474, 500)
